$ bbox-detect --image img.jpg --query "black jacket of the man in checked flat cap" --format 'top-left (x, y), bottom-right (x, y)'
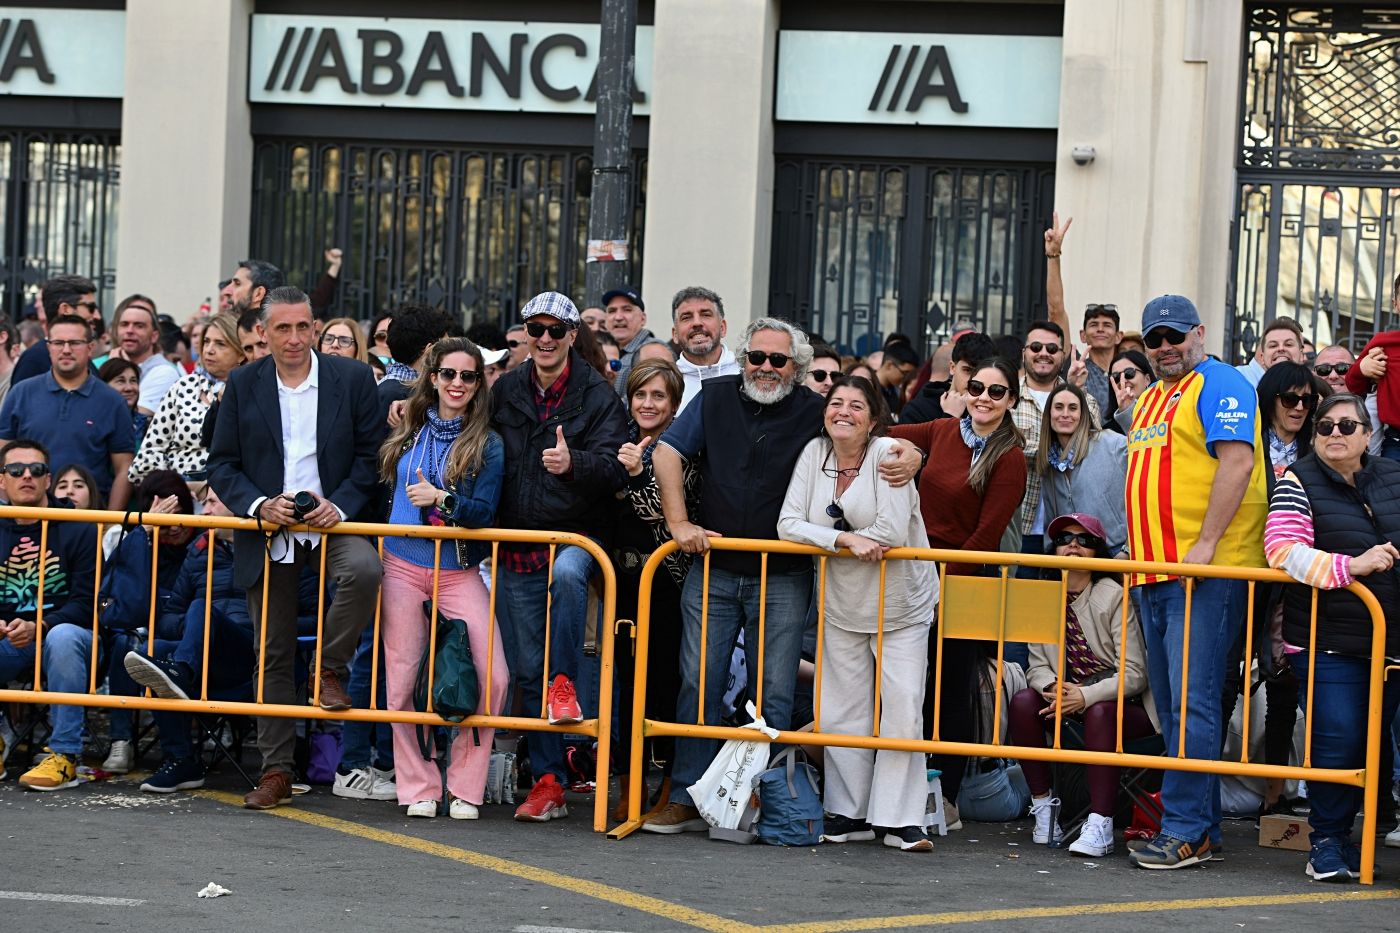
top-left (491, 350), bottom-right (627, 538)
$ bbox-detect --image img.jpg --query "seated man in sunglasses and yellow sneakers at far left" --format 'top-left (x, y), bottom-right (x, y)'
top-left (0, 438), bottom-right (98, 790)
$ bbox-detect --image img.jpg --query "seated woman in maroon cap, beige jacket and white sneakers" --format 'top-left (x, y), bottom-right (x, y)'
top-left (1011, 513), bottom-right (1158, 859)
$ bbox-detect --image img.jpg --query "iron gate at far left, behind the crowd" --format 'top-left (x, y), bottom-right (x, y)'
top-left (0, 130), bottom-right (120, 319)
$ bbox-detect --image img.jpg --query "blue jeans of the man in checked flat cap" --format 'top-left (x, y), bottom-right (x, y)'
top-left (496, 546), bottom-right (596, 785)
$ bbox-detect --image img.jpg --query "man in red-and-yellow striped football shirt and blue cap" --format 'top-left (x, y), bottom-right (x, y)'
top-left (1127, 294), bottom-right (1268, 869)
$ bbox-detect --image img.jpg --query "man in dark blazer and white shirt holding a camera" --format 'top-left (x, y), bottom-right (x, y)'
top-left (209, 287), bottom-right (384, 810)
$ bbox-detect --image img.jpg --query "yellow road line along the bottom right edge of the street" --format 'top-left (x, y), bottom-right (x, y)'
top-left (763, 891), bottom-right (1400, 933)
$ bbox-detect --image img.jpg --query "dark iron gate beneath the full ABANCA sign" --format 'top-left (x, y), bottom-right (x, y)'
top-left (251, 140), bottom-right (645, 324)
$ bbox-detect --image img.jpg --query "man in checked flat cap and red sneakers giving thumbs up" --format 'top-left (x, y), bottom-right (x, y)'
top-left (491, 291), bottom-right (627, 822)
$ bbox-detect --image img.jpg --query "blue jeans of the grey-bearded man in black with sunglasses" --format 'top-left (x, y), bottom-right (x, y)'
top-left (671, 562), bottom-right (812, 806)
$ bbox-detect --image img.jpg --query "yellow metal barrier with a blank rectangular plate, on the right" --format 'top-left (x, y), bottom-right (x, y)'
top-left (610, 538), bottom-right (1386, 884)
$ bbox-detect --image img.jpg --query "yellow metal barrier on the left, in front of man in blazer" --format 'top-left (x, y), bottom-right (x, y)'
top-left (0, 506), bottom-right (617, 832)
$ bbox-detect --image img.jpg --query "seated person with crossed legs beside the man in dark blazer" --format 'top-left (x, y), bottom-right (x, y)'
top-left (123, 486), bottom-right (255, 794)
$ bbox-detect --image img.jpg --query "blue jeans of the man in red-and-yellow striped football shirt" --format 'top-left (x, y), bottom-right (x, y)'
top-left (1137, 580), bottom-right (1247, 843)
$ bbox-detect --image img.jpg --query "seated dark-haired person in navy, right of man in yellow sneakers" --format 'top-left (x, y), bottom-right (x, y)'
top-left (84, 469), bottom-right (195, 775)
